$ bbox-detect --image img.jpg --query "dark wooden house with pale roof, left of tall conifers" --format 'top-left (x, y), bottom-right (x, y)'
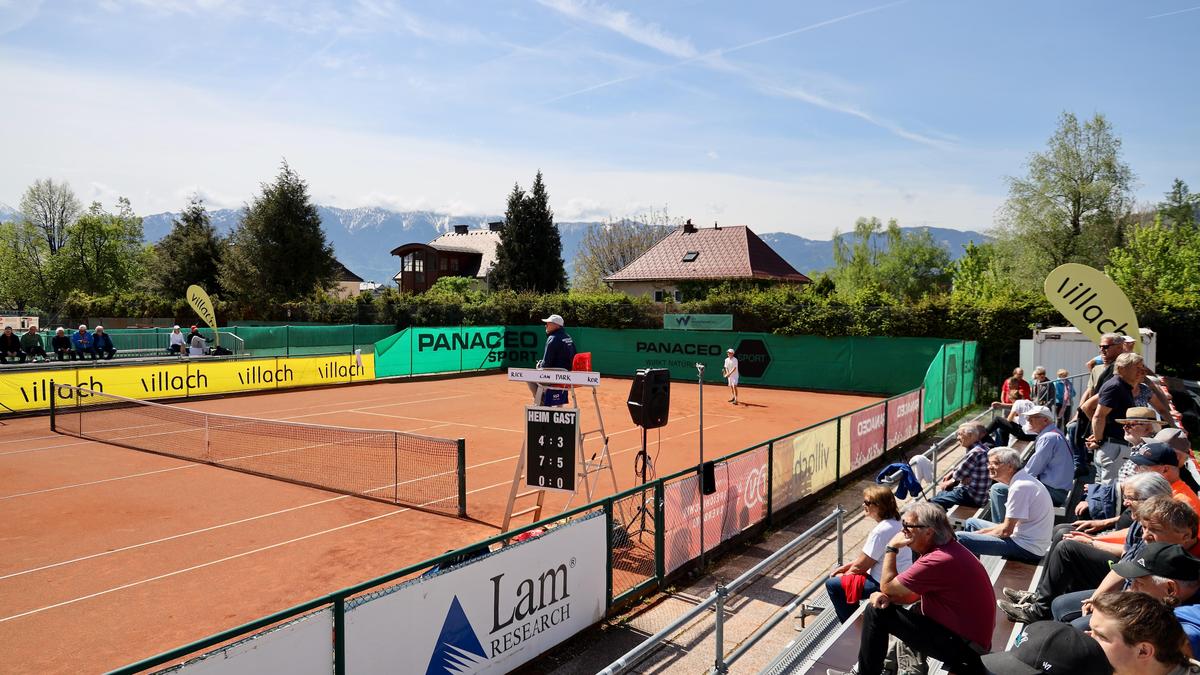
top-left (391, 222), bottom-right (504, 293)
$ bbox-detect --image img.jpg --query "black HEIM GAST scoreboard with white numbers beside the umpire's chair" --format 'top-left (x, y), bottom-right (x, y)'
top-left (526, 406), bottom-right (580, 492)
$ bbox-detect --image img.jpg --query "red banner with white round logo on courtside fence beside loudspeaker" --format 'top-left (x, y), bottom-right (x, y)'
top-left (662, 448), bottom-right (769, 574)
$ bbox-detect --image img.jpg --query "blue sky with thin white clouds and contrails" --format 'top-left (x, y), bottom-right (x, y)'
top-left (0, 0), bottom-right (1200, 238)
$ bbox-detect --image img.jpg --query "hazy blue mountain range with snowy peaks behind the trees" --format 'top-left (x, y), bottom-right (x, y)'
top-left (0, 204), bottom-right (989, 283)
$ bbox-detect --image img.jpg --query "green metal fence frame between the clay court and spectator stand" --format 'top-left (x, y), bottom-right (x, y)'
top-left (110, 342), bottom-right (978, 675)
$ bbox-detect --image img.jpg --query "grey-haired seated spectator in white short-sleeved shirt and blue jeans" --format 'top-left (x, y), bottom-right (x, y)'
top-left (959, 447), bottom-right (1054, 565)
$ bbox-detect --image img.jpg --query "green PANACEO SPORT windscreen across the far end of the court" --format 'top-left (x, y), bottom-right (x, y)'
top-left (376, 325), bottom-right (961, 394)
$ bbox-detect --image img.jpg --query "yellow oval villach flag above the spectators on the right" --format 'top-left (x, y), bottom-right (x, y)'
top-left (1045, 263), bottom-right (1141, 354)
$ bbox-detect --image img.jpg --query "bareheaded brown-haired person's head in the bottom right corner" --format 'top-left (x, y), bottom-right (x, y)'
top-left (1090, 593), bottom-right (1198, 675)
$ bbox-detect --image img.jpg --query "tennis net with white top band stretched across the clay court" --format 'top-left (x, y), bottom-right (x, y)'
top-left (50, 384), bottom-right (467, 518)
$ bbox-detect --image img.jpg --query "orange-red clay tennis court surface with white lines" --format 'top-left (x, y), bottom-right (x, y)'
top-left (0, 375), bottom-right (878, 673)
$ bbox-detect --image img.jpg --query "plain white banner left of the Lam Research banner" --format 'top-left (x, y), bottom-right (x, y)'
top-left (172, 608), bottom-right (334, 675)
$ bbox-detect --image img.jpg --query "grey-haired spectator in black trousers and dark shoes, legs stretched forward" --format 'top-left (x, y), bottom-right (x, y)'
top-left (996, 473), bottom-right (1172, 623)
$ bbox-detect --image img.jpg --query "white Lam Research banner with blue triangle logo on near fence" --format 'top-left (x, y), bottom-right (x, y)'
top-left (346, 513), bottom-right (606, 675)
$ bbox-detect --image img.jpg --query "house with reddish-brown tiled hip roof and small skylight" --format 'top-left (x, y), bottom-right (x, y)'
top-left (605, 220), bottom-right (812, 303)
